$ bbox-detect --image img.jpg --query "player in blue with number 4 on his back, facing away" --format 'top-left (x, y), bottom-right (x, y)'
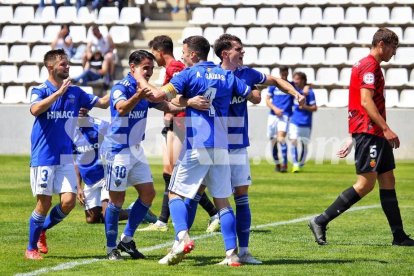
top-left (149, 36), bottom-right (260, 266)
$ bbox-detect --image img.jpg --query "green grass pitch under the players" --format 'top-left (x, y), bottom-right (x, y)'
top-left (0, 156), bottom-right (414, 275)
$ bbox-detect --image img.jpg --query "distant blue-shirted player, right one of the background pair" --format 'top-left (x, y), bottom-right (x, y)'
top-left (289, 72), bottom-right (318, 173)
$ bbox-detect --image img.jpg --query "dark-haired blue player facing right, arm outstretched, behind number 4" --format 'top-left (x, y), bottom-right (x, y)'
top-left (214, 34), bottom-right (304, 264)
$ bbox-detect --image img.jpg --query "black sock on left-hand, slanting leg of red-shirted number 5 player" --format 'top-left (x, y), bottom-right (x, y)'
top-left (315, 187), bottom-right (361, 225)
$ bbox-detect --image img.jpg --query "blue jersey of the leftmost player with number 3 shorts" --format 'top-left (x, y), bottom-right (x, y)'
top-left (30, 81), bottom-right (98, 167)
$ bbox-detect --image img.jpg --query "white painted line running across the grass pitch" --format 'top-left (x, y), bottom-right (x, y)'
top-left (15, 204), bottom-right (380, 276)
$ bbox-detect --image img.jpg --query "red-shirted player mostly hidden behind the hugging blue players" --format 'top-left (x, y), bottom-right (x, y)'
top-left (138, 35), bottom-right (220, 232)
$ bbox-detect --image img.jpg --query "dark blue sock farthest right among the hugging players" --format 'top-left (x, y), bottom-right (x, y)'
top-left (234, 195), bottom-right (252, 247)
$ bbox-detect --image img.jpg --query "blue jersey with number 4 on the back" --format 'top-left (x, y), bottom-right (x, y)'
top-left (170, 61), bottom-right (251, 149)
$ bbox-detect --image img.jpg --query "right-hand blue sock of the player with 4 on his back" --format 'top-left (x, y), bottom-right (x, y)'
top-left (219, 206), bottom-right (237, 251)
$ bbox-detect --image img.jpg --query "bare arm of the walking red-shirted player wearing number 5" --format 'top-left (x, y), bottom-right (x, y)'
top-left (361, 88), bottom-right (400, 149)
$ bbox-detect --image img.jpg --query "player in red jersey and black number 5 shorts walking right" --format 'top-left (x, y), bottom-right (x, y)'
top-left (309, 28), bottom-right (414, 246)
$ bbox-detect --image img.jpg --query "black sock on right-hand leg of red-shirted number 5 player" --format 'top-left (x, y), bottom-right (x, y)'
top-left (380, 189), bottom-right (407, 241)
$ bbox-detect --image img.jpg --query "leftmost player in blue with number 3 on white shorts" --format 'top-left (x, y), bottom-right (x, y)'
top-left (25, 49), bottom-right (108, 260)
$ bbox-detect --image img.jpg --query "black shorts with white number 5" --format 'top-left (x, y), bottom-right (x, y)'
top-left (352, 133), bottom-right (395, 174)
